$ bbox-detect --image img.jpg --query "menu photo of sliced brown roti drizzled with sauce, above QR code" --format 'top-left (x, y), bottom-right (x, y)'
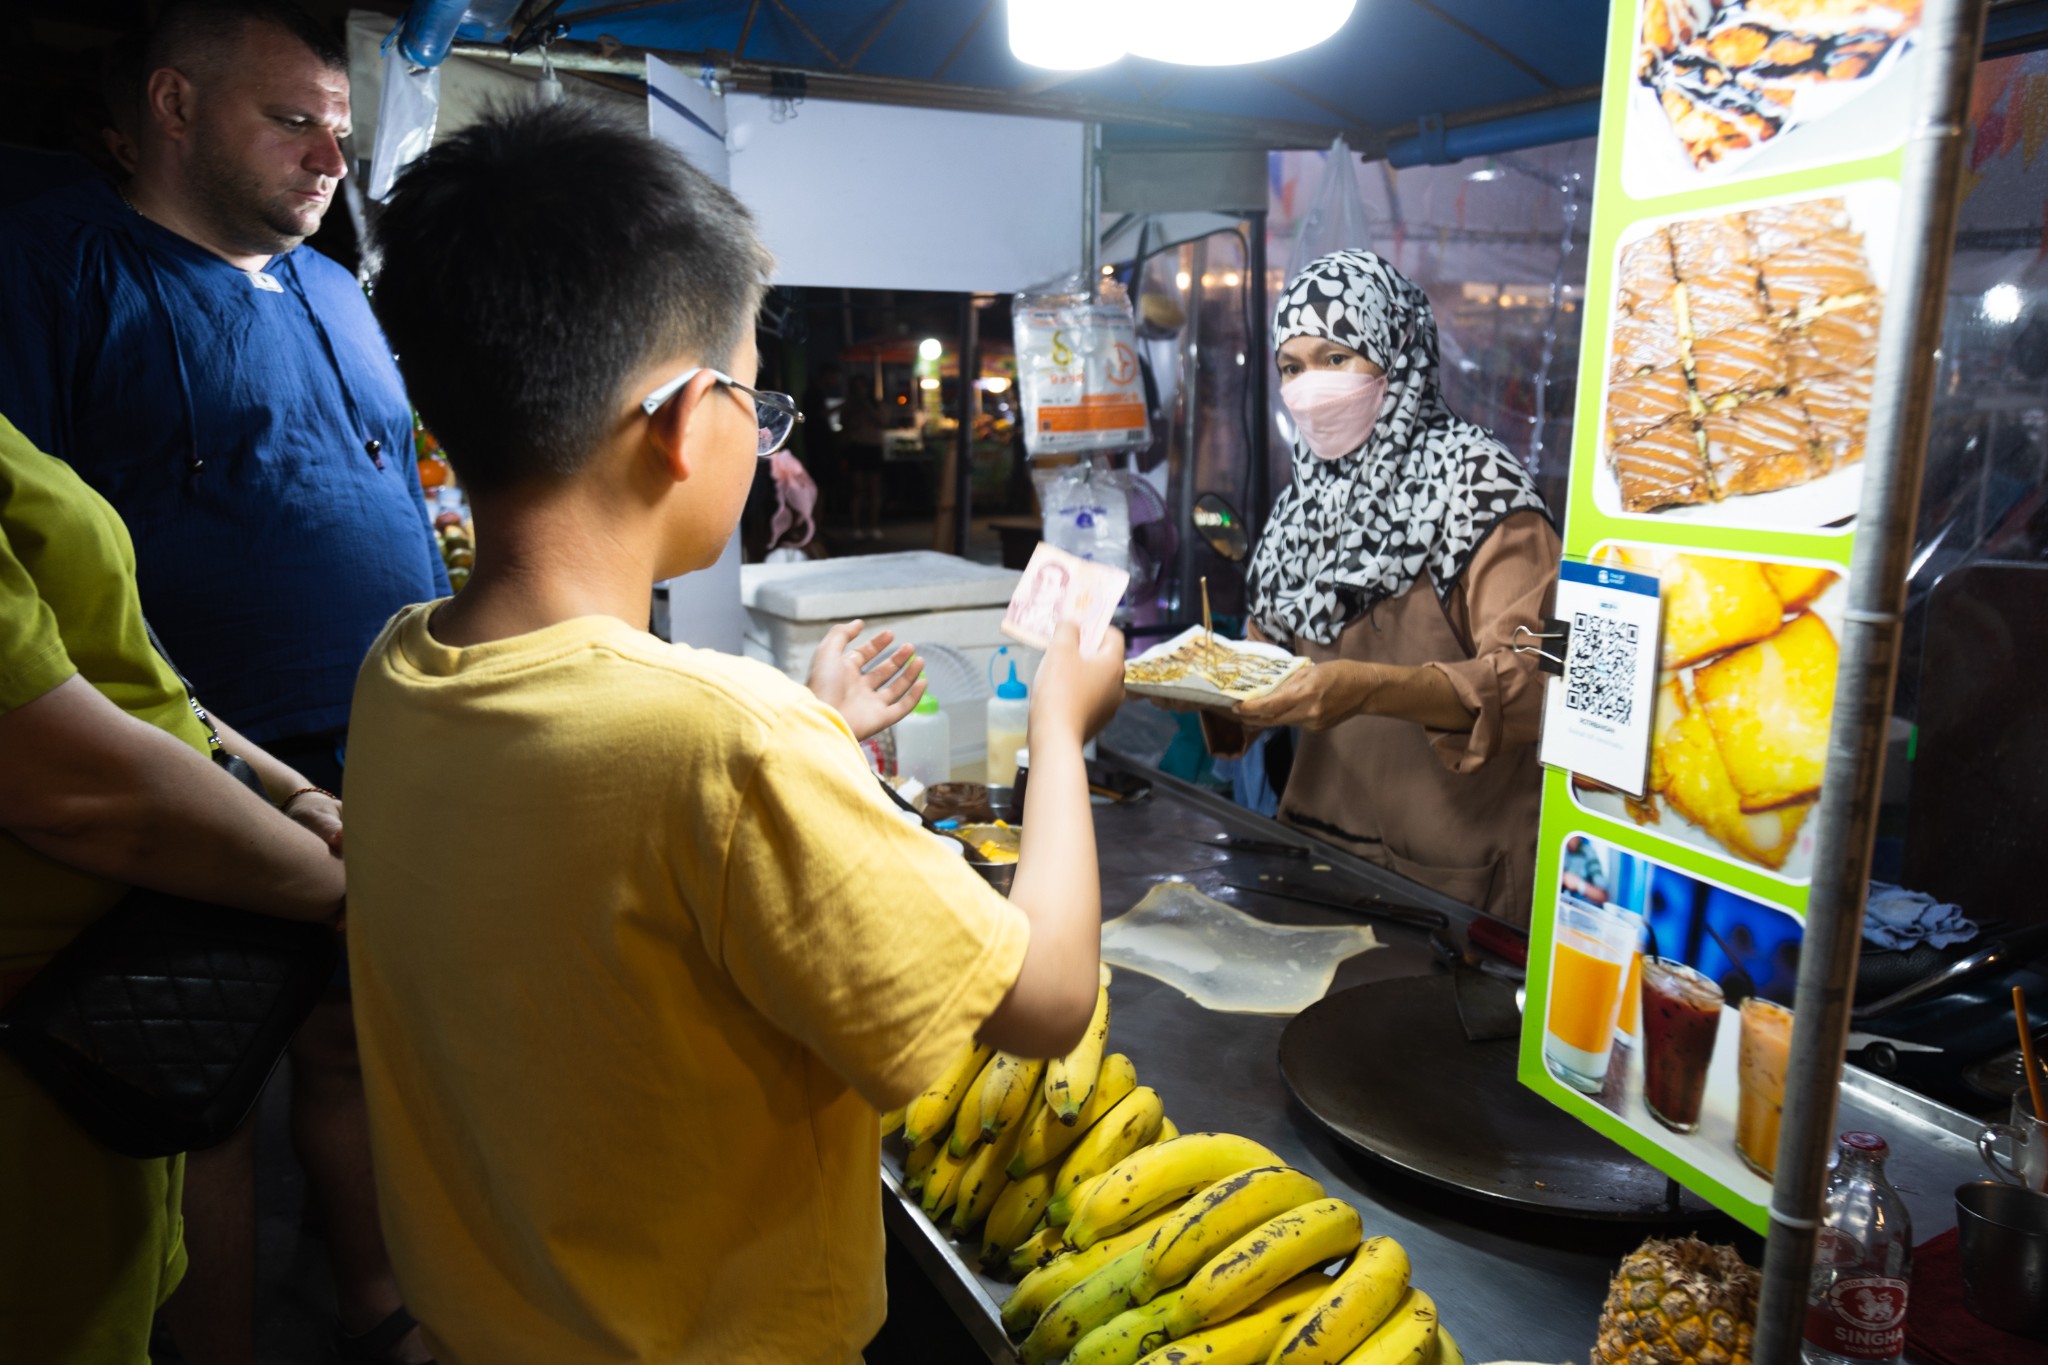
top-left (1593, 184), bottom-right (1892, 530)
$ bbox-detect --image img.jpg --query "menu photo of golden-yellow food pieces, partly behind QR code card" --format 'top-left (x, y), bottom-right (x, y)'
top-left (1573, 544), bottom-right (1847, 882)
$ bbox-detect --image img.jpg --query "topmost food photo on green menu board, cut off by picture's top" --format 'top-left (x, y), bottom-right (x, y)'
top-left (1622, 0), bottom-right (1921, 199)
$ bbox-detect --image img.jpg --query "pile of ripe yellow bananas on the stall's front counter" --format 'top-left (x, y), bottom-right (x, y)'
top-left (883, 968), bottom-right (1464, 1365)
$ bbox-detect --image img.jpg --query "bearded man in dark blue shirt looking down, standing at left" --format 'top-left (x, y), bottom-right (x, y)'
top-left (0, 0), bottom-right (449, 1359)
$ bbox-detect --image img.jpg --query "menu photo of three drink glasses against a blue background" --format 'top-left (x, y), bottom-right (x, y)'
top-left (1542, 833), bottom-right (1802, 1203)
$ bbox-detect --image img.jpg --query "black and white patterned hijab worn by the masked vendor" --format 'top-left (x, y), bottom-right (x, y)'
top-left (1247, 252), bottom-right (1548, 645)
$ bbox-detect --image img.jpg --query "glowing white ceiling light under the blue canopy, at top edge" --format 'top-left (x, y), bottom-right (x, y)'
top-left (1008, 0), bottom-right (1358, 72)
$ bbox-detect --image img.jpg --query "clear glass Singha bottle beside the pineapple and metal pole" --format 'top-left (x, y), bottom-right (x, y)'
top-left (1802, 1134), bottom-right (1913, 1365)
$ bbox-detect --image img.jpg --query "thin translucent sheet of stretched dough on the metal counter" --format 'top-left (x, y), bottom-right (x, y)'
top-left (1102, 882), bottom-right (1380, 1015)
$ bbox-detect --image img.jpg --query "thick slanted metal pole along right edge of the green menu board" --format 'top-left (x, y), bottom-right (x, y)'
top-left (1755, 0), bottom-right (1985, 1365)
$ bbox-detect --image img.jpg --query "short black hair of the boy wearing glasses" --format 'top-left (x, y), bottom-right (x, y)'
top-left (375, 104), bottom-right (772, 491)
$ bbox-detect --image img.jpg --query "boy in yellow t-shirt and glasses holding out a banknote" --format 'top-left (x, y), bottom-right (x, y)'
top-left (348, 106), bottom-right (1122, 1365)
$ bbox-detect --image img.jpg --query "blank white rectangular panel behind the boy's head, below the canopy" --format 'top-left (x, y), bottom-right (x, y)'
top-left (725, 94), bottom-right (1081, 293)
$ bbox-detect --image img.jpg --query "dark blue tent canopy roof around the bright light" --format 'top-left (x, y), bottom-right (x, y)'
top-left (408, 0), bottom-right (2048, 164)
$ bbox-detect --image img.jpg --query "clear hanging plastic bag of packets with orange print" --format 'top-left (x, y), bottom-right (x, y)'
top-left (1010, 276), bottom-right (1151, 458)
